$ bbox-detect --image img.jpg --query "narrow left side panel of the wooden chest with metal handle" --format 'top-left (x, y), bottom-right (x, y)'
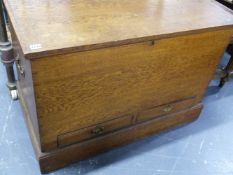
top-left (9, 19), bottom-right (40, 146)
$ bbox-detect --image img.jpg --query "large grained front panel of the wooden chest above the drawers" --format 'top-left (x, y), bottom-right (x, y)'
top-left (32, 30), bottom-right (232, 150)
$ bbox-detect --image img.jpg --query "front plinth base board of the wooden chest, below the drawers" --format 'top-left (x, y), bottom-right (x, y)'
top-left (39, 104), bottom-right (202, 173)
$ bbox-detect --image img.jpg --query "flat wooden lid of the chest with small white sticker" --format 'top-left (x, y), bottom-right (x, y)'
top-left (4, 0), bottom-right (233, 58)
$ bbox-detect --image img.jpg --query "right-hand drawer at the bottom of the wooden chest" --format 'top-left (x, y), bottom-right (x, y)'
top-left (137, 97), bottom-right (195, 122)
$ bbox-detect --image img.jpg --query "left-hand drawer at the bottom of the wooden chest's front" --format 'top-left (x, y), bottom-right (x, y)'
top-left (58, 115), bottom-right (133, 147)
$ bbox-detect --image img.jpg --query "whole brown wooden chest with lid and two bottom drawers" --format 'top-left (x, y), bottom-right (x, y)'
top-left (4, 0), bottom-right (233, 172)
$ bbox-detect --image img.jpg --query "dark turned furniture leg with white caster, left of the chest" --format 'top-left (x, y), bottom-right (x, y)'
top-left (0, 0), bottom-right (18, 100)
